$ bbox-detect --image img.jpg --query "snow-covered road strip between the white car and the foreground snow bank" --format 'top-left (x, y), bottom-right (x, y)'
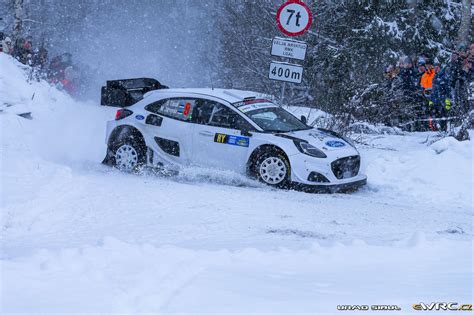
top-left (3, 151), bottom-right (472, 252)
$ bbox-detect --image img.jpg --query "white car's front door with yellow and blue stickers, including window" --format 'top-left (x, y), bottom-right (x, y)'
top-left (192, 99), bottom-right (252, 172)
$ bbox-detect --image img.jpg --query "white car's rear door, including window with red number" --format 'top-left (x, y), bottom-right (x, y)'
top-left (143, 97), bottom-right (196, 165)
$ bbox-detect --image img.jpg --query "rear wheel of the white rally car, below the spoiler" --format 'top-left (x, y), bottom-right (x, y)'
top-left (112, 137), bottom-right (146, 172)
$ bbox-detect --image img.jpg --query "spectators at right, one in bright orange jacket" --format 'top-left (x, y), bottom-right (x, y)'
top-left (384, 44), bottom-right (474, 131)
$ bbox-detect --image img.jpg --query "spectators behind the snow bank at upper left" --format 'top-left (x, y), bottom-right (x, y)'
top-left (0, 32), bottom-right (78, 96)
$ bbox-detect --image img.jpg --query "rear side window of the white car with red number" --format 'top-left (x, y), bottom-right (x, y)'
top-left (145, 98), bottom-right (196, 121)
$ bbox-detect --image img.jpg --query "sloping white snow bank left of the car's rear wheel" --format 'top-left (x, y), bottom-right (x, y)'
top-left (0, 53), bottom-right (113, 204)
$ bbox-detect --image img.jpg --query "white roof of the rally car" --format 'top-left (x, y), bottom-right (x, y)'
top-left (144, 88), bottom-right (273, 103)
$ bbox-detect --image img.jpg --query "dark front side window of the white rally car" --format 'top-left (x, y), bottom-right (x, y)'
top-left (192, 99), bottom-right (253, 130)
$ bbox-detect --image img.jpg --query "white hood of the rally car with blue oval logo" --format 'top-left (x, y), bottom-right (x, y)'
top-left (285, 128), bottom-right (354, 151)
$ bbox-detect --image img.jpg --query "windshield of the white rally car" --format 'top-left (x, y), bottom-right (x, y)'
top-left (238, 103), bottom-right (310, 132)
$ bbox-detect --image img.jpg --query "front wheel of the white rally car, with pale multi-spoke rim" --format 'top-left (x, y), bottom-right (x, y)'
top-left (253, 149), bottom-right (291, 188)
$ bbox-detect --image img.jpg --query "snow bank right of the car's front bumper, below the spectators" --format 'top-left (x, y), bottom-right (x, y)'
top-left (363, 133), bottom-right (474, 211)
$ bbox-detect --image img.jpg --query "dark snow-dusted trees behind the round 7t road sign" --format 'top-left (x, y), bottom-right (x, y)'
top-left (218, 0), bottom-right (468, 126)
